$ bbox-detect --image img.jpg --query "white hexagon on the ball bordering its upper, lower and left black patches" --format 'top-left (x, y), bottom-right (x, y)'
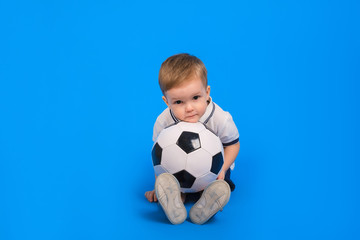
top-left (161, 144), bottom-right (187, 174)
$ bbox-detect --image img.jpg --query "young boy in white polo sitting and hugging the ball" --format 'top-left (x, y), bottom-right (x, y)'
top-left (145, 54), bottom-right (240, 224)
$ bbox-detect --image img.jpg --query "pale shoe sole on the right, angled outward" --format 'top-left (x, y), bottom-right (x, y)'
top-left (189, 180), bottom-right (231, 224)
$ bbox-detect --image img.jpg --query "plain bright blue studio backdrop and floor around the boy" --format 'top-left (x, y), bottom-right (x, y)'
top-left (0, 0), bottom-right (360, 240)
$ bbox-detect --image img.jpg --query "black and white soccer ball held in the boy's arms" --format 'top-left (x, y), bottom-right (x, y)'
top-left (152, 122), bottom-right (224, 193)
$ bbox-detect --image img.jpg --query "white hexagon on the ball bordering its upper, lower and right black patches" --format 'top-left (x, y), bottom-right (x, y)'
top-left (186, 148), bottom-right (212, 177)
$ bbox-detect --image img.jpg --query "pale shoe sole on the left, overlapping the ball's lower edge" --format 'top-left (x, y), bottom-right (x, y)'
top-left (155, 173), bottom-right (187, 224)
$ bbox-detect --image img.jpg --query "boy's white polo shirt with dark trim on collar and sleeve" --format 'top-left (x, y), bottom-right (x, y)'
top-left (153, 98), bottom-right (239, 169)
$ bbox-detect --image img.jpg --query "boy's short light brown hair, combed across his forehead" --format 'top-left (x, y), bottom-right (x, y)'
top-left (159, 53), bottom-right (207, 94)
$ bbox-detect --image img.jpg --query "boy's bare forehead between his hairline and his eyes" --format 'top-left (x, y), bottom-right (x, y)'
top-left (165, 77), bottom-right (206, 99)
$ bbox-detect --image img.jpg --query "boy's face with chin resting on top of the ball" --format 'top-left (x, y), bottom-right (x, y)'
top-left (163, 76), bottom-right (210, 123)
